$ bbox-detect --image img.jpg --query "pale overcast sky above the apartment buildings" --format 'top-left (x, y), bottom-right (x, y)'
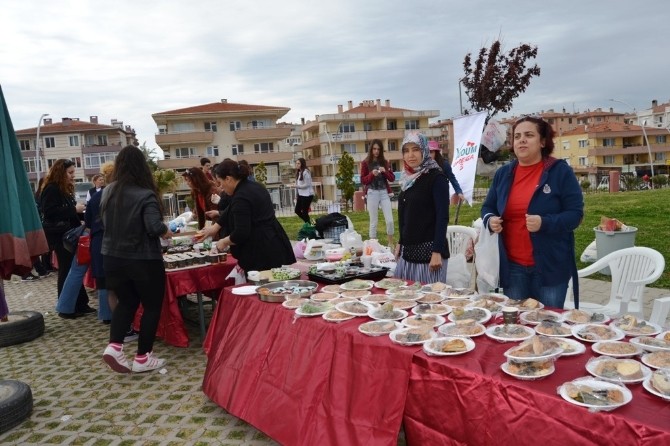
top-left (0, 0), bottom-right (670, 155)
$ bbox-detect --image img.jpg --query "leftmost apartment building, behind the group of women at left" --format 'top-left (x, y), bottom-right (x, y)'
top-left (16, 116), bottom-right (137, 189)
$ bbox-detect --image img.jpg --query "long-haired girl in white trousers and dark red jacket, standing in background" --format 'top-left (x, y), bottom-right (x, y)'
top-left (361, 139), bottom-right (395, 248)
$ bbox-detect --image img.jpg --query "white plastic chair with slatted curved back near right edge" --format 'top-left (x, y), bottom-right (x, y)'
top-left (564, 246), bottom-right (665, 319)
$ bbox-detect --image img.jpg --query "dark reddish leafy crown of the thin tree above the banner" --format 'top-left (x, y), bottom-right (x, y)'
top-left (461, 40), bottom-right (540, 117)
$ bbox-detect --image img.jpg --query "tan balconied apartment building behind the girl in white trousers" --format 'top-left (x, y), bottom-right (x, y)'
top-left (298, 99), bottom-right (441, 201)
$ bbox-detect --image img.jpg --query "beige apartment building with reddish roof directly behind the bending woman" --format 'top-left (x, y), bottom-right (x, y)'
top-left (151, 99), bottom-right (301, 207)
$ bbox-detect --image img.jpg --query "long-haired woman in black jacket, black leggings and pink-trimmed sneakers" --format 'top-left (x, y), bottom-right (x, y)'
top-left (100, 146), bottom-right (172, 373)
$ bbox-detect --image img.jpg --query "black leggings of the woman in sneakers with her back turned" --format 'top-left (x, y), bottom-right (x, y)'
top-left (104, 257), bottom-right (165, 355)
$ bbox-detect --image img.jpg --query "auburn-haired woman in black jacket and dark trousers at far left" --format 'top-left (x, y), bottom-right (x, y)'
top-left (40, 159), bottom-right (95, 319)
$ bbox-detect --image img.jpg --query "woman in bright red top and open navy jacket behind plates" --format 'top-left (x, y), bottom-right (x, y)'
top-left (482, 116), bottom-right (584, 308)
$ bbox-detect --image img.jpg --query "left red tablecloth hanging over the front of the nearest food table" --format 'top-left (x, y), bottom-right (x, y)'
top-left (203, 289), bottom-right (417, 446)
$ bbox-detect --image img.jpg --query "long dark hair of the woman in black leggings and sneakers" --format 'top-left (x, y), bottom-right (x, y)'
top-left (102, 145), bottom-right (163, 217)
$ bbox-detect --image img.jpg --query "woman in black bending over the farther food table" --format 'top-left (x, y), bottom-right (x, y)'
top-left (214, 160), bottom-right (295, 271)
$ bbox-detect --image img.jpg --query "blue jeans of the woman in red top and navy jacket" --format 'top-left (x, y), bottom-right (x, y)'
top-left (503, 262), bottom-right (568, 308)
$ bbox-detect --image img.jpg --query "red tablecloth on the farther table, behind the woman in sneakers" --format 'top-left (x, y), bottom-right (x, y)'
top-left (143, 255), bottom-right (237, 347)
